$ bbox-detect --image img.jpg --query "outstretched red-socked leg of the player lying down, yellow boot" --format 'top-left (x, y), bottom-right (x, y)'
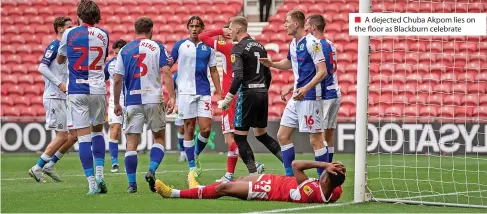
top-left (156, 180), bottom-right (249, 200)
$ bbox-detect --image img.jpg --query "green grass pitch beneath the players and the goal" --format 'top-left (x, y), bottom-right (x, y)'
top-left (1, 153), bottom-right (487, 213)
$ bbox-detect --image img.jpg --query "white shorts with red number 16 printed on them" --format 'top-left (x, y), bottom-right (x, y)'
top-left (281, 99), bottom-right (323, 133)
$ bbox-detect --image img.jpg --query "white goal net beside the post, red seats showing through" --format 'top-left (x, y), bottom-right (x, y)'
top-left (356, 0), bottom-right (487, 208)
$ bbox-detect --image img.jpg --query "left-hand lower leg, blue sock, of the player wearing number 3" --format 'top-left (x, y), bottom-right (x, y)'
top-left (125, 133), bottom-right (140, 193)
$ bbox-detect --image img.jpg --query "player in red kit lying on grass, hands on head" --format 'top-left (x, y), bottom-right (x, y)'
top-left (156, 160), bottom-right (346, 203)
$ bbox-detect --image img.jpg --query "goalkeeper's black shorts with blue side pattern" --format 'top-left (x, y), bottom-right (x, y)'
top-left (233, 92), bottom-right (269, 131)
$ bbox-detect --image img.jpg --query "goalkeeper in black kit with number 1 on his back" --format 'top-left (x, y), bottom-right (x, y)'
top-left (218, 17), bottom-right (282, 174)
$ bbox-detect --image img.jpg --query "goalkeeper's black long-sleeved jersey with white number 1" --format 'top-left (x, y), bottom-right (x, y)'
top-left (229, 36), bottom-right (271, 94)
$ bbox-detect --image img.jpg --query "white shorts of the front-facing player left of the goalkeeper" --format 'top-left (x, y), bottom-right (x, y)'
top-left (178, 94), bottom-right (213, 120)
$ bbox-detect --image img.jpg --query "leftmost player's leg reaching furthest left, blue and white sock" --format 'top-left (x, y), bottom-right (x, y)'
top-left (29, 131), bottom-right (68, 183)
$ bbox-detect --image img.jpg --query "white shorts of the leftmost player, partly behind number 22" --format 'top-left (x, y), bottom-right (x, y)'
top-left (44, 99), bottom-right (68, 132)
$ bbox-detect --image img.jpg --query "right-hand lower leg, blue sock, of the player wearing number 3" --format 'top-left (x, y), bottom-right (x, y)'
top-left (145, 129), bottom-right (166, 192)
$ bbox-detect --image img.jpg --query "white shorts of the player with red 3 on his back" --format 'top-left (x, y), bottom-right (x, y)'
top-left (123, 103), bottom-right (166, 134)
